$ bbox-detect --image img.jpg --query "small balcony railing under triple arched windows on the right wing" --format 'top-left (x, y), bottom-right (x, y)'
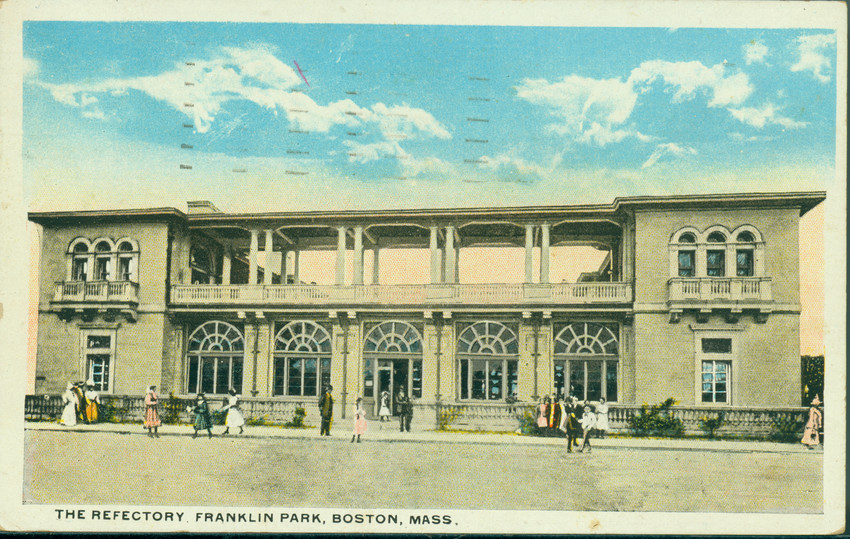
top-left (668, 277), bottom-right (773, 304)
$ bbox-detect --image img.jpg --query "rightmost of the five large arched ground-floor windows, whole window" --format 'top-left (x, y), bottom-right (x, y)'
top-left (554, 322), bottom-right (620, 402)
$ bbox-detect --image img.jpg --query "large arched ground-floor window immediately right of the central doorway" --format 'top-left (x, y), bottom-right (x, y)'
top-left (457, 321), bottom-right (519, 400)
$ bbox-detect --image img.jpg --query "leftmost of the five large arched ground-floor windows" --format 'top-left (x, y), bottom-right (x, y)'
top-left (187, 320), bottom-right (245, 395)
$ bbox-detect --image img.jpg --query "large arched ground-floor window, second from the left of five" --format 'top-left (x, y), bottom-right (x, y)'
top-left (273, 320), bottom-right (331, 397)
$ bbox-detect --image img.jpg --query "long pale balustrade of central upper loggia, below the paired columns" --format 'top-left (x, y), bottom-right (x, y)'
top-left (171, 282), bottom-right (632, 306)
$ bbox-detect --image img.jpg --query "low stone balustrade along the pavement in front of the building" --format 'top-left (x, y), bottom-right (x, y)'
top-left (24, 395), bottom-right (807, 439)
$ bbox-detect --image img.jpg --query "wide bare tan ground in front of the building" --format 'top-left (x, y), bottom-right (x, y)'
top-left (24, 422), bottom-right (823, 513)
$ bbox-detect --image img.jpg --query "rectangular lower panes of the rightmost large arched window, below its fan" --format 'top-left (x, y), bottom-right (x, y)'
top-left (554, 359), bottom-right (619, 402)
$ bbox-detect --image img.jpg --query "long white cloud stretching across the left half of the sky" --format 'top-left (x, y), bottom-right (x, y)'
top-left (29, 46), bottom-right (451, 159)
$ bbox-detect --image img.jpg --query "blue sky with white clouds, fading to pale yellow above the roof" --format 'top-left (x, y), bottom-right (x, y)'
top-left (23, 22), bottom-right (836, 211)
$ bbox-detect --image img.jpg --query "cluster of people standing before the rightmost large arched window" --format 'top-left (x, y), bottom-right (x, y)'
top-left (537, 394), bottom-right (610, 453)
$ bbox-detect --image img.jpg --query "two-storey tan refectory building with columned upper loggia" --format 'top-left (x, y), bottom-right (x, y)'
top-left (29, 192), bottom-right (825, 424)
